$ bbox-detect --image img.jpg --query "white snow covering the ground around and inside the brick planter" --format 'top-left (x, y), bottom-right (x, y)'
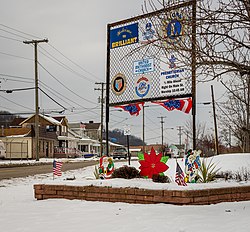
top-left (0, 154), bottom-right (250, 232)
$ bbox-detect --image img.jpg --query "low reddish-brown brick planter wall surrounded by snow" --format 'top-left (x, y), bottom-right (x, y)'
top-left (34, 184), bottom-right (250, 205)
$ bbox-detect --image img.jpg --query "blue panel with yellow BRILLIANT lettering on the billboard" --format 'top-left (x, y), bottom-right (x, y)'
top-left (110, 23), bottom-right (139, 49)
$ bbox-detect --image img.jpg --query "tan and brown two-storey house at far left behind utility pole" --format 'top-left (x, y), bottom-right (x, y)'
top-left (1, 114), bottom-right (73, 159)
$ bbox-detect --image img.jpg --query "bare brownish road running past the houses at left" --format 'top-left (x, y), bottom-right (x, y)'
top-left (0, 160), bottom-right (98, 180)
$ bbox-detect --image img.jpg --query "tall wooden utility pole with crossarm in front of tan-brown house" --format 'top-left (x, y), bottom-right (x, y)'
top-left (23, 39), bottom-right (49, 161)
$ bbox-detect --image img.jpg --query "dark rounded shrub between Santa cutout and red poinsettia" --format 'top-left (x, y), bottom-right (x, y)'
top-left (111, 165), bottom-right (141, 179)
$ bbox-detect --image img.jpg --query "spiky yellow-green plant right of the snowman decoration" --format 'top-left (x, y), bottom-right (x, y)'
top-left (197, 159), bottom-right (220, 183)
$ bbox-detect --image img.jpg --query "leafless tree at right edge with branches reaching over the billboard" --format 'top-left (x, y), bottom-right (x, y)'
top-left (140, 0), bottom-right (250, 152)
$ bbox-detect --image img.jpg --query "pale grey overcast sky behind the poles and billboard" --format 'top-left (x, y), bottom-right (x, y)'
top-left (0, 0), bottom-right (221, 144)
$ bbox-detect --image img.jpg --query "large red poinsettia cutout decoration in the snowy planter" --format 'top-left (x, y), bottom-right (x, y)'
top-left (139, 147), bottom-right (168, 178)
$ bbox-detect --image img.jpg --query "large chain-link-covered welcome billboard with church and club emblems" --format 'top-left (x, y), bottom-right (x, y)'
top-left (107, 1), bottom-right (193, 106)
